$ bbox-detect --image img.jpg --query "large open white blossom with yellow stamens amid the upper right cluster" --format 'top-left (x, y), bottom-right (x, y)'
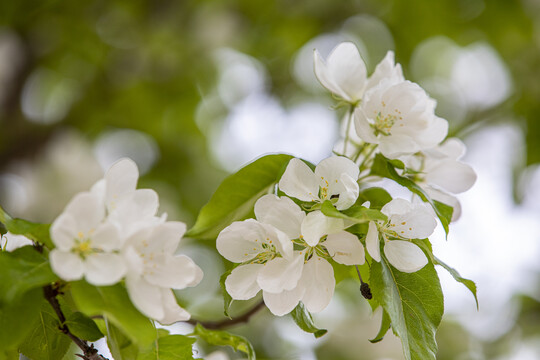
top-left (354, 79), bottom-right (448, 158)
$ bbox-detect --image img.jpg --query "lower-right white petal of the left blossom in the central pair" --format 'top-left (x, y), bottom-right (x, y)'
top-left (257, 253), bottom-right (304, 293)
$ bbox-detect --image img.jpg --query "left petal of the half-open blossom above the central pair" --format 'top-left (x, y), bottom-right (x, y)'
top-left (279, 158), bottom-right (319, 201)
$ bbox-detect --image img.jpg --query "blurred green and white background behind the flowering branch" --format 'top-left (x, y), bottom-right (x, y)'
top-left (0, 0), bottom-right (540, 360)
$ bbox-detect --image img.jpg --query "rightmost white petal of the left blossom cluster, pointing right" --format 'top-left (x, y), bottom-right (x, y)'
top-left (144, 255), bottom-right (200, 289)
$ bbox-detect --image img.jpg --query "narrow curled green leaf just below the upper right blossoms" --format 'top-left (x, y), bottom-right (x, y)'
top-left (370, 154), bottom-right (453, 235)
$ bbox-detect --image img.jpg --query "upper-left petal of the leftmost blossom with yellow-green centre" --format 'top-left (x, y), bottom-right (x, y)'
top-left (64, 192), bottom-right (105, 235)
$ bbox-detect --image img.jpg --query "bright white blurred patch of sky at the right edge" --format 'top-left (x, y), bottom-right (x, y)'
top-left (432, 126), bottom-right (540, 339)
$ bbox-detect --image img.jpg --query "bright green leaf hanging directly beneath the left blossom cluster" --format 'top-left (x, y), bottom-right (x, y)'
top-left (71, 281), bottom-right (156, 347)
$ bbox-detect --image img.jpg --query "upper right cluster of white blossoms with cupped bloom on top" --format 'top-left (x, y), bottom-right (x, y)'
top-left (314, 42), bottom-right (476, 220)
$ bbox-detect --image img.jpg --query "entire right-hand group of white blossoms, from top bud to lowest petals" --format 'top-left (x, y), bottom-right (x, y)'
top-left (216, 42), bottom-right (476, 315)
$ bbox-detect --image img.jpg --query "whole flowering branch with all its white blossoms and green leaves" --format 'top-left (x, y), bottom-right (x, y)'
top-left (0, 42), bottom-right (476, 360)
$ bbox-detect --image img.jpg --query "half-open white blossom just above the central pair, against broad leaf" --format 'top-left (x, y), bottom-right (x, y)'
top-left (279, 156), bottom-right (359, 210)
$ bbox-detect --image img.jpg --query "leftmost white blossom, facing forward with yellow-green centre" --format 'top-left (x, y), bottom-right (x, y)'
top-left (49, 192), bottom-right (127, 285)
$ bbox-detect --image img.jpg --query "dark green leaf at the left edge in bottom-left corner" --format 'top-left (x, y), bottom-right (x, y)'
top-left (0, 289), bottom-right (44, 350)
